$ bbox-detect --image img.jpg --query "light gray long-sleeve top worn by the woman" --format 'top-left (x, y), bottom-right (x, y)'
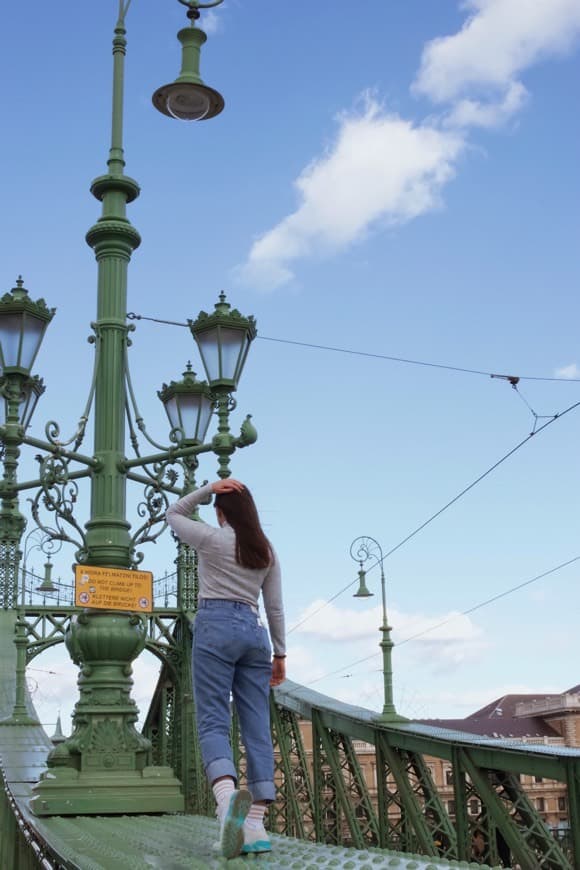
top-left (166, 483), bottom-right (286, 655)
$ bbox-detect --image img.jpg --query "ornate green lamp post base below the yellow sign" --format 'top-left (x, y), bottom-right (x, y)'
top-left (30, 610), bottom-right (184, 816)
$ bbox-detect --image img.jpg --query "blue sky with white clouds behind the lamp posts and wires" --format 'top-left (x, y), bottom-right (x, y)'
top-left (0, 0), bottom-right (580, 730)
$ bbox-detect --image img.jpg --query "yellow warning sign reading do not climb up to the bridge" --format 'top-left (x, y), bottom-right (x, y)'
top-left (75, 565), bottom-right (153, 613)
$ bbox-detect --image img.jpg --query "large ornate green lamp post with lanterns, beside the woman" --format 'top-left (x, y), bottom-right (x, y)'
top-left (0, 0), bottom-right (257, 816)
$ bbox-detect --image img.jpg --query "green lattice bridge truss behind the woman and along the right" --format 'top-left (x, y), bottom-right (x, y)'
top-left (0, 575), bottom-right (580, 870)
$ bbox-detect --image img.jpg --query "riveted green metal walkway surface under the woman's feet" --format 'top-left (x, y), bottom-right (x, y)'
top-left (0, 611), bottom-right (490, 870)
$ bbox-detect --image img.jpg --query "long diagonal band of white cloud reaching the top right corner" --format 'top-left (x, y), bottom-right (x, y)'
top-left (234, 0), bottom-right (580, 289)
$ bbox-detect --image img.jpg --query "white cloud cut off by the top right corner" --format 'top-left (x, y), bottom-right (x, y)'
top-left (414, 0), bottom-right (580, 103)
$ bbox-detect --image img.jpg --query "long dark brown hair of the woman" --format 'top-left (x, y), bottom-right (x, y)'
top-left (214, 487), bottom-right (273, 568)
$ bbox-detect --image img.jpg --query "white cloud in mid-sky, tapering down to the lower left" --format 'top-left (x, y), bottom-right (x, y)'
top-left (237, 94), bottom-right (464, 289)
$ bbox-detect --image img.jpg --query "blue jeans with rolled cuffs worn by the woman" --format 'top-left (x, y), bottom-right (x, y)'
top-left (193, 598), bottom-right (276, 801)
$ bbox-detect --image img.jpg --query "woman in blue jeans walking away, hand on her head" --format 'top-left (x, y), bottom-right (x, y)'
top-left (167, 479), bottom-right (286, 858)
